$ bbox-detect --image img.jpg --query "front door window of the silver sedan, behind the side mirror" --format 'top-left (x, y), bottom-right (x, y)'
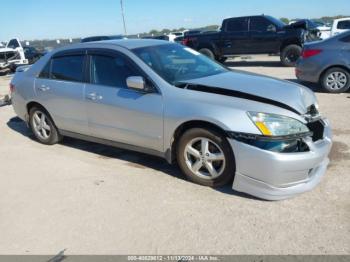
top-left (90, 55), bottom-right (142, 88)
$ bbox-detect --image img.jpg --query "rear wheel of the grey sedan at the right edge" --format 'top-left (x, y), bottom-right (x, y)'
top-left (320, 67), bottom-right (350, 94)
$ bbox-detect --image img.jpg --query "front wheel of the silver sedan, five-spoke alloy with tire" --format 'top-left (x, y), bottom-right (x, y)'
top-left (177, 128), bottom-right (236, 187)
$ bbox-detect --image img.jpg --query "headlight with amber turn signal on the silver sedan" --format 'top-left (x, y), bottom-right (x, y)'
top-left (248, 112), bottom-right (310, 137)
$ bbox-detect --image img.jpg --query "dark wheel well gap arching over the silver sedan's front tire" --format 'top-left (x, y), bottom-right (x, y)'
top-left (166, 120), bottom-right (228, 163)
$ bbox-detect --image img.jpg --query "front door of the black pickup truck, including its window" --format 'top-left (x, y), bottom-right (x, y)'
top-left (249, 16), bottom-right (280, 54)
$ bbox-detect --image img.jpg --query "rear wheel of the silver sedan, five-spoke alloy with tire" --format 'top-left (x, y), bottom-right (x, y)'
top-left (29, 106), bottom-right (62, 145)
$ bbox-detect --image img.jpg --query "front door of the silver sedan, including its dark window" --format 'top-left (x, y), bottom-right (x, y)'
top-left (86, 50), bottom-right (163, 151)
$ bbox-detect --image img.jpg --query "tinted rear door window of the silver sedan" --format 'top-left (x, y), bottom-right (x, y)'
top-left (51, 55), bottom-right (84, 82)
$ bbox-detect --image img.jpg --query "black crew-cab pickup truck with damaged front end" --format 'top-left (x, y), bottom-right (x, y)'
top-left (182, 15), bottom-right (308, 66)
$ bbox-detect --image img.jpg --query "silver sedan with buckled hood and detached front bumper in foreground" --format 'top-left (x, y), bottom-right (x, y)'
top-left (10, 39), bottom-right (332, 200)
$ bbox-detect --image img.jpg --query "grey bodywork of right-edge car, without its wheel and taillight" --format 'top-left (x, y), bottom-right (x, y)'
top-left (296, 32), bottom-right (350, 83)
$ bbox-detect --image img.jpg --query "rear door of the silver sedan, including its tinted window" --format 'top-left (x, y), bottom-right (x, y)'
top-left (35, 50), bottom-right (88, 134)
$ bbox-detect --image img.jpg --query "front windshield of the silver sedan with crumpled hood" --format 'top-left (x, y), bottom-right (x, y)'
top-left (133, 44), bottom-right (228, 85)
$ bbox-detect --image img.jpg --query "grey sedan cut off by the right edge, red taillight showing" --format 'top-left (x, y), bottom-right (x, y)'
top-left (295, 32), bottom-right (350, 93)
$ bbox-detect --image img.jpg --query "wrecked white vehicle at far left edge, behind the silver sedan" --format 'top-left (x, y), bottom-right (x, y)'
top-left (0, 38), bottom-right (29, 70)
